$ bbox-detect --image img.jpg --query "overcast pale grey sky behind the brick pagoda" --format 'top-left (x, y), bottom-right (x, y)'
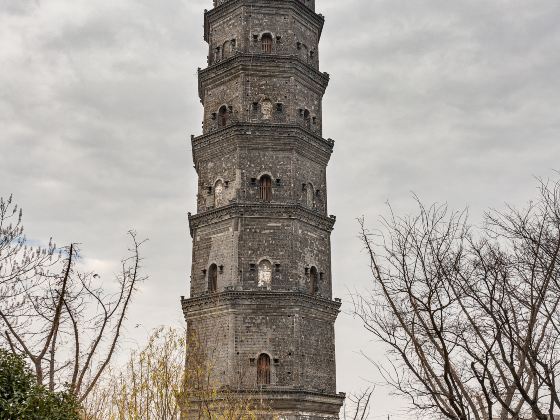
top-left (0, 0), bottom-right (560, 420)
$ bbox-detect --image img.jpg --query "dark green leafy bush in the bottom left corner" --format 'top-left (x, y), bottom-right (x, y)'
top-left (0, 348), bottom-right (80, 420)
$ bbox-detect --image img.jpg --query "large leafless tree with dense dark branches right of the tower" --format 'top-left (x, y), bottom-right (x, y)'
top-left (354, 178), bottom-right (560, 420)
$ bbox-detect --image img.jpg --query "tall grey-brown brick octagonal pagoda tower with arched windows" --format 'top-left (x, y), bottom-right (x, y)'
top-left (182, 0), bottom-right (344, 420)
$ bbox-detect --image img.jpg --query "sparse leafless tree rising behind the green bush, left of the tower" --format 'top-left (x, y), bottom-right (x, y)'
top-left (0, 199), bottom-right (144, 402)
